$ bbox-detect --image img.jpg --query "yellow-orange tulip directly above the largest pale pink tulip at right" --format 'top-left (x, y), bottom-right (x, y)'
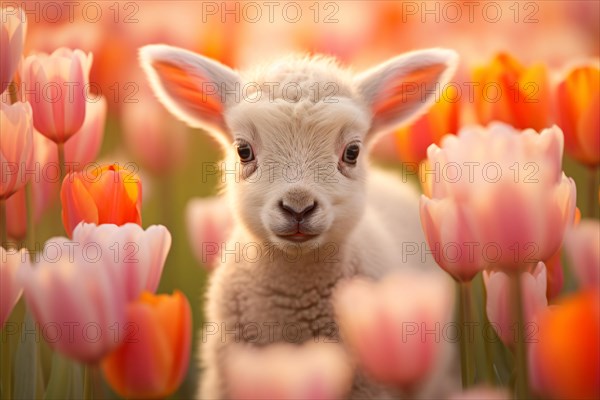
top-left (473, 53), bottom-right (550, 131)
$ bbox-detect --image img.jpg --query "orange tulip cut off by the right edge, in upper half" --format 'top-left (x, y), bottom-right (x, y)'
top-left (556, 66), bottom-right (600, 166)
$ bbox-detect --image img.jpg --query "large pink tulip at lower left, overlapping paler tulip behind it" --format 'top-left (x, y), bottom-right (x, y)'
top-left (19, 231), bottom-right (127, 363)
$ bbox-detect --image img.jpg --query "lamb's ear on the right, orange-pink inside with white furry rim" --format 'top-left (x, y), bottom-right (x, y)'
top-left (355, 49), bottom-right (458, 141)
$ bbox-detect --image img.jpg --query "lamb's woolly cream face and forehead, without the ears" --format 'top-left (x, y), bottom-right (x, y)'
top-left (225, 96), bottom-right (370, 251)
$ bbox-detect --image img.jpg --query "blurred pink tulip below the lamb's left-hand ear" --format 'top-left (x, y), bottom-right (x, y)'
top-left (122, 91), bottom-right (188, 175)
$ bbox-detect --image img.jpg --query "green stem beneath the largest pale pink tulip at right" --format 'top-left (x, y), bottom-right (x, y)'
top-left (510, 272), bottom-right (529, 399)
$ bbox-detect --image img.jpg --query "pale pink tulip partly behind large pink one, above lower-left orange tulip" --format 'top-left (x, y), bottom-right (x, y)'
top-left (73, 223), bottom-right (171, 301)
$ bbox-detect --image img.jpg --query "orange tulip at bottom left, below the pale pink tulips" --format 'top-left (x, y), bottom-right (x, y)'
top-left (102, 291), bottom-right (192, 398)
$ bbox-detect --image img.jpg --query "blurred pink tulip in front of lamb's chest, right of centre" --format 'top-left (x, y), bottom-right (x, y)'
top-left (334, 272), bottom-right (453, 392)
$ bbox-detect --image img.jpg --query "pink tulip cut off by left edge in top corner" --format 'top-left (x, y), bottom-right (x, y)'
top-left (0, 7), bottom-right (27, 94)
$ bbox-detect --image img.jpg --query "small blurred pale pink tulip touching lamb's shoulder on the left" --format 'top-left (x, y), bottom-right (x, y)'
top-left (185, 197), bottom-right (232, 269)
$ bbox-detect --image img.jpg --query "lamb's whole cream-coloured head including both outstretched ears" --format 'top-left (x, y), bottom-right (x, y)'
top-left (140, 45), bottom-right (457, 248)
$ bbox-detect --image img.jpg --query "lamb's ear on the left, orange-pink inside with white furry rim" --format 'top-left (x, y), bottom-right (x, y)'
top-left (140, 45), bottom-right (240, 144)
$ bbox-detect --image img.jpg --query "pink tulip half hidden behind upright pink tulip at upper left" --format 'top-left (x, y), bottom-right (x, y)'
top-left (65, 97), bottom-right (107, 172)
